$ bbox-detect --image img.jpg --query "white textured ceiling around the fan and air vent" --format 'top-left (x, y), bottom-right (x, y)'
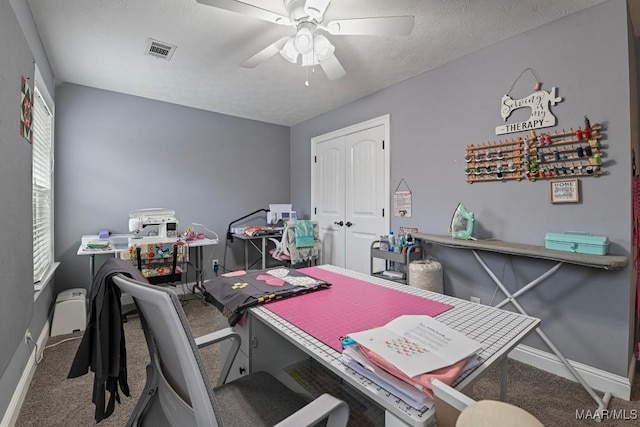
top-left (26, 0), bottom-right (640, 126)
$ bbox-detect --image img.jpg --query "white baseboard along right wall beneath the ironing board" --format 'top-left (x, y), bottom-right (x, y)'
top-left (509, 345), bottom-right (635, 401)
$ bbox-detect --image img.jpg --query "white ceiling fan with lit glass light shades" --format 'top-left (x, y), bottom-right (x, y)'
top-left (196, 0), bottom-right (414, 81)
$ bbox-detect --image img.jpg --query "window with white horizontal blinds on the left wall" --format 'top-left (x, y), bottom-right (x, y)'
top-left (32, 66), bottom-right (56, 291)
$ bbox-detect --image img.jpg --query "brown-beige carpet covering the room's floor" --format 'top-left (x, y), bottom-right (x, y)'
top-left (12, 299), bottom-right (640, 427)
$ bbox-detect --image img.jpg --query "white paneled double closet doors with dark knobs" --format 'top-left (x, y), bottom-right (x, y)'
top-left (311, 116), bottom-right (390, 274)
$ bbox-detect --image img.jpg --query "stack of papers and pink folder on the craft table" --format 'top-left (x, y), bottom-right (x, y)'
top-left (343, 315), bottom-right (482, 407)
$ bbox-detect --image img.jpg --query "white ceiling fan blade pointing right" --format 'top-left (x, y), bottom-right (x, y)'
top-left (326, 16), bottom-right (415, 36)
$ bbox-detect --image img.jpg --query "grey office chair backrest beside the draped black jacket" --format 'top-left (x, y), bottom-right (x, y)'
top-left (113, 275), bottom-right (224, 427)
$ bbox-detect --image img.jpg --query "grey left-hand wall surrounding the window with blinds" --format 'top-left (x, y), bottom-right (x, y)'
top-left (0, 0), bottom-right (53, 414)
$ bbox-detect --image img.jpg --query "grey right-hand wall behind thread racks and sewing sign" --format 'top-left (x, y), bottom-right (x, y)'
top-left (291, 0), bottom-right (637, 376)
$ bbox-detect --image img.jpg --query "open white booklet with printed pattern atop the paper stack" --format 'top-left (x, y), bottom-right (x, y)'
top-left (348, 315), bottom-right (482, 377)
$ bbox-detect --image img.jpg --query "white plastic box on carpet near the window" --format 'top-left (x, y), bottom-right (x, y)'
top-left (51, 288), bottom-right (87, 337)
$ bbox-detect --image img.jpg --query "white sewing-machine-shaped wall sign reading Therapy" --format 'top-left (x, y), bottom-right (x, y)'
top-left (496, 87), bottom-right (562, 135)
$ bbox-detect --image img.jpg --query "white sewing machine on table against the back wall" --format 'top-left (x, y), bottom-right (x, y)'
top-left (129, 208), bottom-right (178, 244)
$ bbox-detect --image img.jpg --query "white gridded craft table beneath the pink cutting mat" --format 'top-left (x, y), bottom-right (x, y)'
top-left (220, 265), bottom-right (540, 427)
